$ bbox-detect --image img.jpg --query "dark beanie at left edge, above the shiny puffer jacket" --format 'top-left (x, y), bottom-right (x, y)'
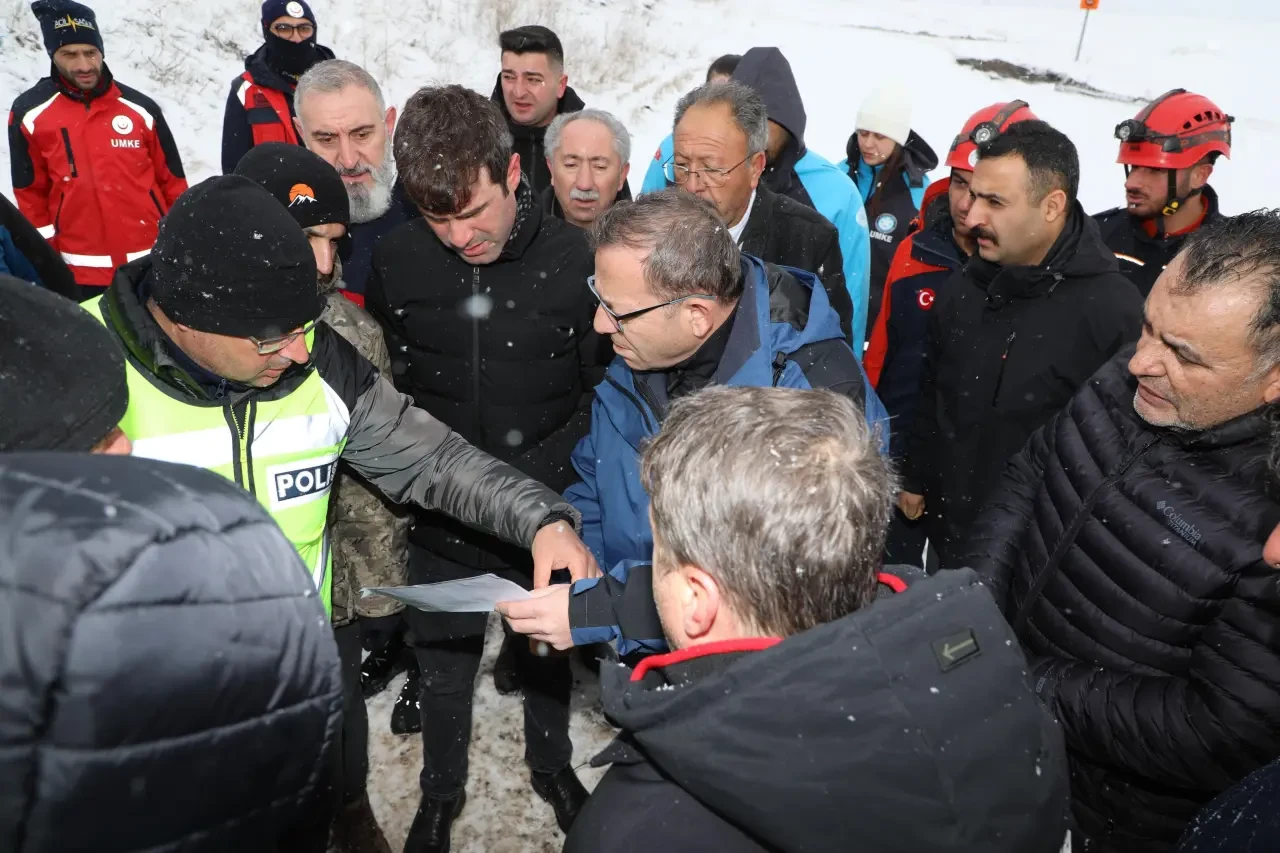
top-left (0, 275), bottom-right (129, 452)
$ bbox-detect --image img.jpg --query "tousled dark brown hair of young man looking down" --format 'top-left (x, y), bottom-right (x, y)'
top-left (394, 86), bottom-right (512, 216)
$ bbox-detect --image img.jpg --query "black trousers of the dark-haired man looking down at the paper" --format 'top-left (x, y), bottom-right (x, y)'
top-left (404, 546), bottom-right (573, 798)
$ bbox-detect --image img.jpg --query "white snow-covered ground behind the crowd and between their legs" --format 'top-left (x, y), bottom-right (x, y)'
top-left (0, 0), bottom-right (1280, 853)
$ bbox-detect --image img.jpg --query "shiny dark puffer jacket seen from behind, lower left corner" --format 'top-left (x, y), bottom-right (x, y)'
top-left (0, 453), bottom-right (342, 853)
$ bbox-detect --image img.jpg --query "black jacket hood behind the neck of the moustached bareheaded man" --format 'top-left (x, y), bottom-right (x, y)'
top-left (965, 201), bottom-right (1120, 301)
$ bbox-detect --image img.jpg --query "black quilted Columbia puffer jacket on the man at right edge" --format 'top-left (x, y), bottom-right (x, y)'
top-left (968, 347), bottom-right (1280, 853)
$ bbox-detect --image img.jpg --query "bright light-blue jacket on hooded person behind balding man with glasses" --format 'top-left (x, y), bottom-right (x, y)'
top-left (640, 136), bottom-right (872, 352)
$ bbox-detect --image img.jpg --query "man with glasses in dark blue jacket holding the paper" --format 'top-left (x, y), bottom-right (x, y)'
top-left (498, 190), bottom-right (888, 656)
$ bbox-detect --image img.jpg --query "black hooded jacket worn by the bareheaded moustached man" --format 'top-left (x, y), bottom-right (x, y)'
top-left (902, 204), bottom-right (1142, 569)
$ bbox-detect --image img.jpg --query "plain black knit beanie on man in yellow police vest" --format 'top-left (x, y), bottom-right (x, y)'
top-left (151, 174), bottom-right (324, 338)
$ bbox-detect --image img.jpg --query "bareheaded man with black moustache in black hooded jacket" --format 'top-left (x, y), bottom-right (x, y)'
top-left (899, 120), bottom-right (1142, 569)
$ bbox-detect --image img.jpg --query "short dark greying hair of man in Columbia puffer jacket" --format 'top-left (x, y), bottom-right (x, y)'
top-left (1174, 209), bottom-right (1280, 375)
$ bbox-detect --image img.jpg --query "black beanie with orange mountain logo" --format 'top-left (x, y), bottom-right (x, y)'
top-left (236, 142), bottom-right (351, 228)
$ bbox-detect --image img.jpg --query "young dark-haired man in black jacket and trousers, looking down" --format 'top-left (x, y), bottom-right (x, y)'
top-left (367, 86), bottom-right (604, 853)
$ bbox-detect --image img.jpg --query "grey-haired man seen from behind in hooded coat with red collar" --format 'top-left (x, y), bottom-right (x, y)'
top-left (564, 386), bottom-right (1069, 853)
